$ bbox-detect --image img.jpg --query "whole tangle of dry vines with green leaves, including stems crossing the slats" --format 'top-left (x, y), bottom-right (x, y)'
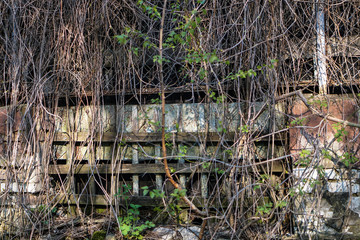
top-left (0, 0), bottom-right (360, 239)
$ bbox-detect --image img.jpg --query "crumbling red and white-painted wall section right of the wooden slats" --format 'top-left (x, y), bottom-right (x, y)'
top-left (290, 95), bottom-right (360, 239)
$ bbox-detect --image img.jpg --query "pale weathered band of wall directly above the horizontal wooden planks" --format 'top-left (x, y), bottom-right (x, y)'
top-left (55, 102), bottom-right (285, 133)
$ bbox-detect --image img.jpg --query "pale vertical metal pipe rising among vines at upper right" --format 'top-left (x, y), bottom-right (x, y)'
top-left (314, 0), bottom-right (328, 94)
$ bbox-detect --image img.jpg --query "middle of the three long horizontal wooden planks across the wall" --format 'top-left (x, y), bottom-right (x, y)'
top-left (49, 161), bottom-right (284, 175)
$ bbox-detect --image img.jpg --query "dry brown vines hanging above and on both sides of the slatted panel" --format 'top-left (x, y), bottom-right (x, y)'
top-left (0, 0), bottom-right (360, 239)
